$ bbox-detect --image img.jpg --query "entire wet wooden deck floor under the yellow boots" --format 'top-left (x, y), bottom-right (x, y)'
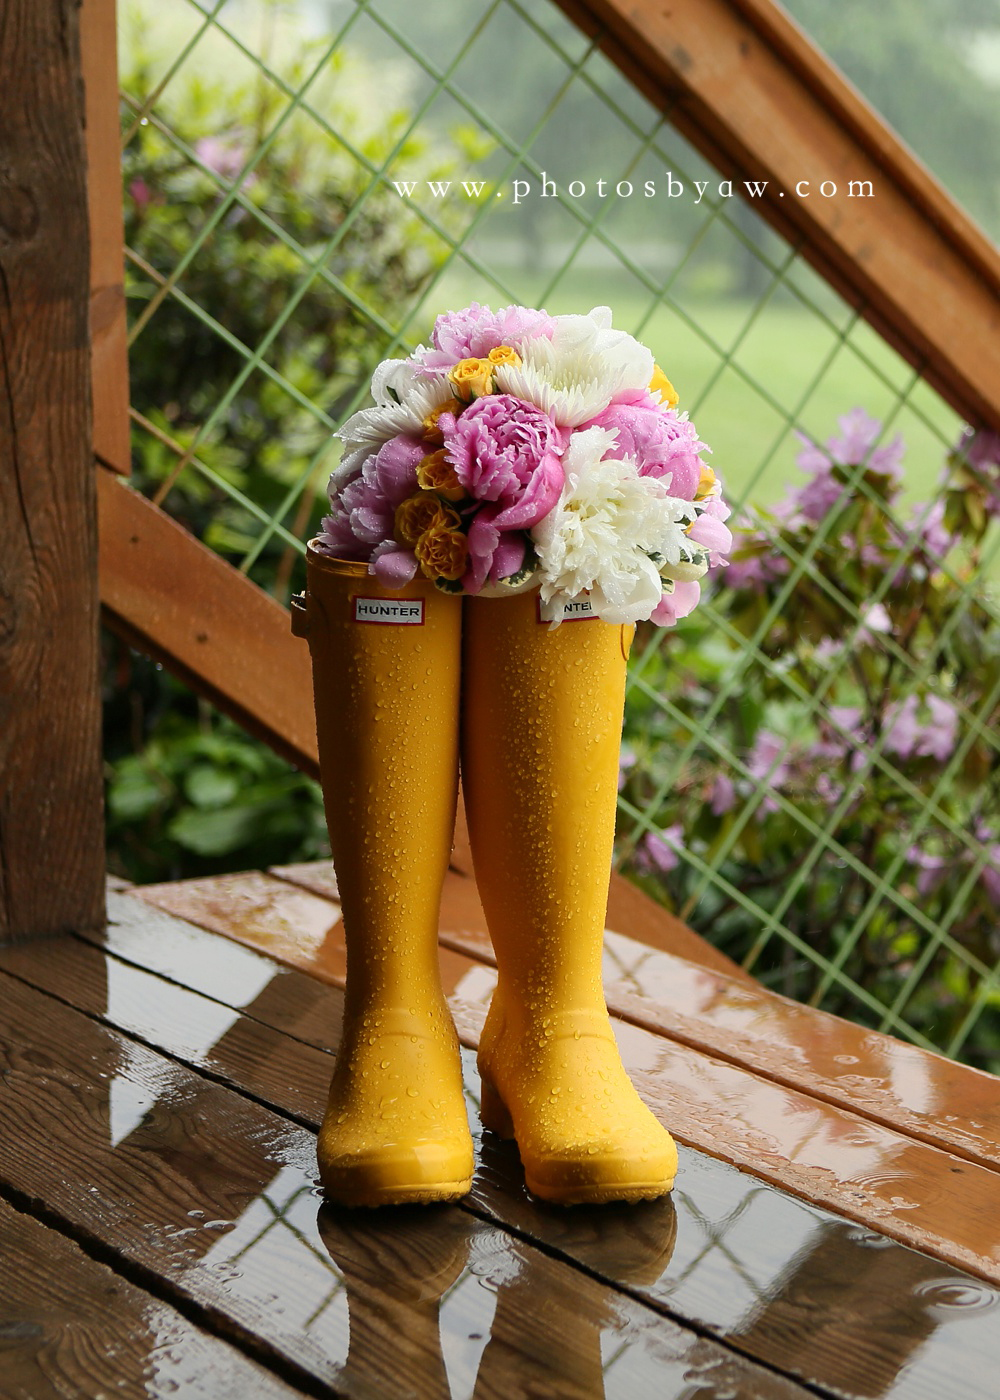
top-left (0, 867), bottom-right (1000, 1400)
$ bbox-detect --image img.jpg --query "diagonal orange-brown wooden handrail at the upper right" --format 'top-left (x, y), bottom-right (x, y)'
top-left (549, 0), bottom-right (1000, 428)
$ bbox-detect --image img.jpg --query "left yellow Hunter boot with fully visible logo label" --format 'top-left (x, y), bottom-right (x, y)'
top-left (296, 547), bottom-right (473, 1205)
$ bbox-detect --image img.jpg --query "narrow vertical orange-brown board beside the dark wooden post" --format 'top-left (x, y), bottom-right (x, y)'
top-left (80, 0), bottom-right (132, 475)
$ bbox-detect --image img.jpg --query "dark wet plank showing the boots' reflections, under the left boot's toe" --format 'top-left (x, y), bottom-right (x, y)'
top-left (0, 976), bottom-right (804, 1400)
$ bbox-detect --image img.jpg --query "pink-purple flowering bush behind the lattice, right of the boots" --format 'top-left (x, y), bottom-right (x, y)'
top-left (622, 410), bottom-right (1000, 1068)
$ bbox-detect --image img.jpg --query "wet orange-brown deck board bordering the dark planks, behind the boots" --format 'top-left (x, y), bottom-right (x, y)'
top-left (120, 875), bottom-right (1000, 1282)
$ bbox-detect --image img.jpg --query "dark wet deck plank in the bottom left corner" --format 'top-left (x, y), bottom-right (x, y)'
top-left (0, 1201), bottom-right (301, 1400)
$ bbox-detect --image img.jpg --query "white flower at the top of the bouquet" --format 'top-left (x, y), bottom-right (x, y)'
top-left (496, 307), bottom-right (654, 427)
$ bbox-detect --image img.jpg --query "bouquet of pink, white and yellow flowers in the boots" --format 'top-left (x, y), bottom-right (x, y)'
top-left (318, 302), bottom-right (732, 626)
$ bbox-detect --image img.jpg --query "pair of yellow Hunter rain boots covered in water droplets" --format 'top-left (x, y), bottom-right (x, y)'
top-left (292, 549), bottom-right (676, 1205)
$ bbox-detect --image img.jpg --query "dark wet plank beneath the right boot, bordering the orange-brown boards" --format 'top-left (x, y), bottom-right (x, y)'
top-left (6, 902), bottom-right (1000, 1397)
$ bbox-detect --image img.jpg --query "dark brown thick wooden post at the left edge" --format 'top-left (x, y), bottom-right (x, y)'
top-left (0, 0), bottom-right (104, 941)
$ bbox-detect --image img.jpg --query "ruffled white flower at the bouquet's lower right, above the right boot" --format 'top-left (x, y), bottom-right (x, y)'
top-left (531, 428), bottom-right (696, 623)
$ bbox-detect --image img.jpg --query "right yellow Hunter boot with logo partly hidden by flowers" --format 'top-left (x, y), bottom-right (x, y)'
top-left (462, 592), bottom-right (676, 1205)
